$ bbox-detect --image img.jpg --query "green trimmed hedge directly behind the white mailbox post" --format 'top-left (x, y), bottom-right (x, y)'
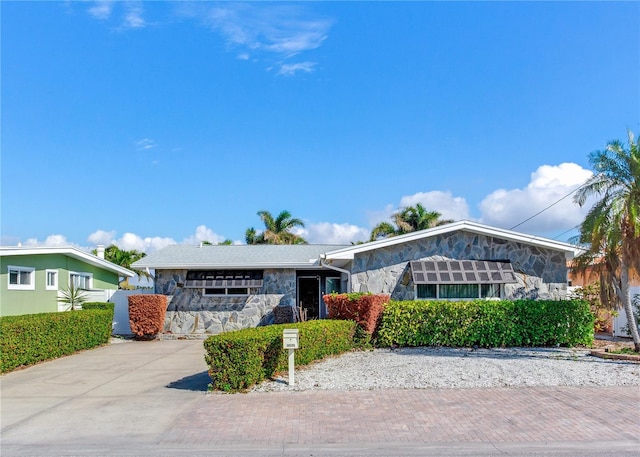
top-left (204, 320), bottom-right (356, 392)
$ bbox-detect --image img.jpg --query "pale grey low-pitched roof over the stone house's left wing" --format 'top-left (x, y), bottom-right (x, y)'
top-left (132, 244), bottom-right (346, 269)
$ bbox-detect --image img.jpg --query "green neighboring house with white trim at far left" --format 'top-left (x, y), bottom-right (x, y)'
top-left (0, 246), bottom-right (135, 316)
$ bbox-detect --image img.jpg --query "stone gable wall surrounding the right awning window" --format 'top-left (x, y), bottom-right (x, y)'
top-left (351, 231), bottom-right (567, 300)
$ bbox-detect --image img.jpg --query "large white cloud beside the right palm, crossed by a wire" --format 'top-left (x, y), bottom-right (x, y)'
top-left (480, 163), bottom-right (592, 234)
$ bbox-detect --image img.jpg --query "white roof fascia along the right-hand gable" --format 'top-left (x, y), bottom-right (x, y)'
top-left (326, 221), bottom-right (581, 260)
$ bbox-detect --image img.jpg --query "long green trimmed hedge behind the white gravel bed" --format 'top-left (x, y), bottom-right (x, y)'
top-left (377, 300), bottom-right (593, 347)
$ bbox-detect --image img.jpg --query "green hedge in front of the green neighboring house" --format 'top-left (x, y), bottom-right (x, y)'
top-left (0, 303), bottom-right (113, 373)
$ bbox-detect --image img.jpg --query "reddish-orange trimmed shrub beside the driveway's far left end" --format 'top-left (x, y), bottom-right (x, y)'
top-left (128, 294), bottom-right (167, 338)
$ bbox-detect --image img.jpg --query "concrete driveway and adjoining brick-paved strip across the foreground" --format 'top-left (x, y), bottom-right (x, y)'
top-left (0, 340), bottom-right (640, 457)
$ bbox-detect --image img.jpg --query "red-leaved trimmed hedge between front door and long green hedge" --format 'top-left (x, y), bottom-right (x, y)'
top-left (322, 293), bottom-right (389, 335)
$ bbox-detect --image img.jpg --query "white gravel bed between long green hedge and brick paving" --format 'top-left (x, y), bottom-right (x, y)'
top-left (252, 348), bottom-right (640, 392)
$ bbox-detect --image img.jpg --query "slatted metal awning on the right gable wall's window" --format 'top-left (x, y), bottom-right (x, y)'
top-left (410, 260), bottom-right (516, 284)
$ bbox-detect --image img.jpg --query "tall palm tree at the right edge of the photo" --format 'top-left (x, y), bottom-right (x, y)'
top-left (572, 131), bottom-right (640, 352)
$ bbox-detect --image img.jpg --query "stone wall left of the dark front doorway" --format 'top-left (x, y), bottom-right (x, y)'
top-left (155, 269), bottom-right (296, 334)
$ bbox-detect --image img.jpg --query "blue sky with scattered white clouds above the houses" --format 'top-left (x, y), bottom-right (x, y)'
top-left (0, 1), bottom-right (640, 252)
